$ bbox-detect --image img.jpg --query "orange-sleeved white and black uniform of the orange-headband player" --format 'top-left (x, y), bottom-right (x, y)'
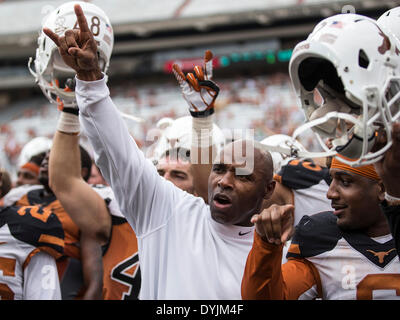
top-left (242, 212), bottom-right (400, 300)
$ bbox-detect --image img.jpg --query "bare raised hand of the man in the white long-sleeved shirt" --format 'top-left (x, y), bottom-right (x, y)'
top-left (43, 4), bottom-right (102, 80)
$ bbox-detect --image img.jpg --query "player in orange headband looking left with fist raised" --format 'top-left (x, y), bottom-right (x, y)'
top-left (242, 158), bottom-right (400, 300)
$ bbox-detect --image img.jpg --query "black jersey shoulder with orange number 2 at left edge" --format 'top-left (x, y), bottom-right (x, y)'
top-left (0, 205), bottom-right (64, 258)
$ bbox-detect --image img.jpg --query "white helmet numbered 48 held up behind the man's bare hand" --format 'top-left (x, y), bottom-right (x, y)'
top-left (28, 1), bottom-right (114, 107)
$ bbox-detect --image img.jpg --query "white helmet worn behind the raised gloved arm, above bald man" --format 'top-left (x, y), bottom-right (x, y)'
top-left (152, 116), bottom-right (225, 162)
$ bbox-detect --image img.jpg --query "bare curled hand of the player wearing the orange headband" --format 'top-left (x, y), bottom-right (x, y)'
top-left (251, 204), bottom-right (294, 244)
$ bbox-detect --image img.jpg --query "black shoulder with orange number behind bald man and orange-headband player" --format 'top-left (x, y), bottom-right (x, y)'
top-left (278, 159), bottom-right (331, 190)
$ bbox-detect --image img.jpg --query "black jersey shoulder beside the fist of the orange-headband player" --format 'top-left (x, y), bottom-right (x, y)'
top-left (287, 211), bottom-right (342, 258)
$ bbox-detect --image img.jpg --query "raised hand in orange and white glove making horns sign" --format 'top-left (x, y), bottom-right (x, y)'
top-left (172, 50), bottom-right (219, 118)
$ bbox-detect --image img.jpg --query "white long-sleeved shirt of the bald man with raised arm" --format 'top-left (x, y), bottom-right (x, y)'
top-left (75, 79), bottom-right (254, 299)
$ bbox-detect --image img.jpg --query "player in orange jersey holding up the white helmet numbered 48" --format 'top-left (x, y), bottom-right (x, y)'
top-left (34, 1), bottom-right (141, 300)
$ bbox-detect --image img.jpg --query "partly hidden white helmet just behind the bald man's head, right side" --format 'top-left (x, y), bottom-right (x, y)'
top-left (261, 134), bottom-right (307, 173)
